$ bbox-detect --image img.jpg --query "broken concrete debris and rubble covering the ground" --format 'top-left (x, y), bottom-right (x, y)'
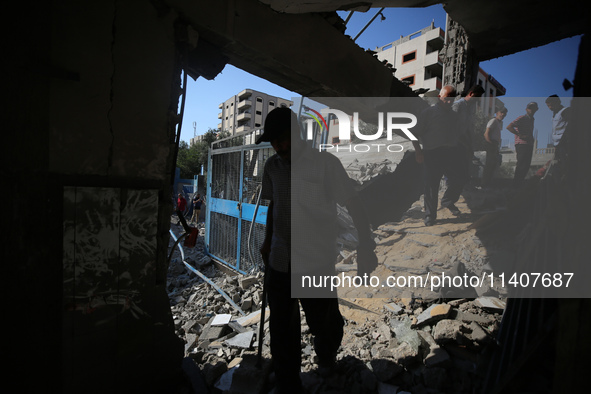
top-left (167, 197), bottom-right (506, 394)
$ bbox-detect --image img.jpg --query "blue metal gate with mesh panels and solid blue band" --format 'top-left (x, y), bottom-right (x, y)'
top-left (205, 129), bottom-right (275, 274)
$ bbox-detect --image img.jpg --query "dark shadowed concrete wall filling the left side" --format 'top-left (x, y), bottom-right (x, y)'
top-left (2, 0), bottom-right (182, 392)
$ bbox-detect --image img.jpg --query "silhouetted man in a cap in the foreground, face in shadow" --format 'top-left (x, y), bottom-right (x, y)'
top-left (256, 108), bottom-right (377, 393)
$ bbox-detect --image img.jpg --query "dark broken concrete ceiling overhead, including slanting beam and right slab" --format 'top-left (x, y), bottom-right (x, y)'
top-left (166, 0), bottom-right (587, 101)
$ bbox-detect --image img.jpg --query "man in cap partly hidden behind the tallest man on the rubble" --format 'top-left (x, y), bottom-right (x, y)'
top-left (452, 85), bottom-right (484, 182)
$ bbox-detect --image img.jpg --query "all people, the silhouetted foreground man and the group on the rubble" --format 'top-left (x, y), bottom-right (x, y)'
top-left (230, 91), bottom-right (567, 393)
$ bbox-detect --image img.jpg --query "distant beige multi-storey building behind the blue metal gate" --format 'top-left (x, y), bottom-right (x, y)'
top-left (218, 89), bottom-right (293, 135)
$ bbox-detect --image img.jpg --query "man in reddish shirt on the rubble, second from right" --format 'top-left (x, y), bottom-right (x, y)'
top-left (507, 101), bottom-right (538, 186)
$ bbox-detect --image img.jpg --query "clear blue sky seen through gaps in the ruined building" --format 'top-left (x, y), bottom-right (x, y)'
top-left (181, 5), bottom-right (580, 146)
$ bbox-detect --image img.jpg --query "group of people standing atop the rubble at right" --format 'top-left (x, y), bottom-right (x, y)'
top-left (413, 85), bottom-right (568, 226)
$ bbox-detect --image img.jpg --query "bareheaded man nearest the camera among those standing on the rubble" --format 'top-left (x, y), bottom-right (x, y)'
top-left (413, 85), bottom-right (467, 226)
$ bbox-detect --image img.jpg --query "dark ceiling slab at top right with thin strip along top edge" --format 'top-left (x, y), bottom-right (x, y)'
top-left (260, 0), bottom-right (588, 61)
